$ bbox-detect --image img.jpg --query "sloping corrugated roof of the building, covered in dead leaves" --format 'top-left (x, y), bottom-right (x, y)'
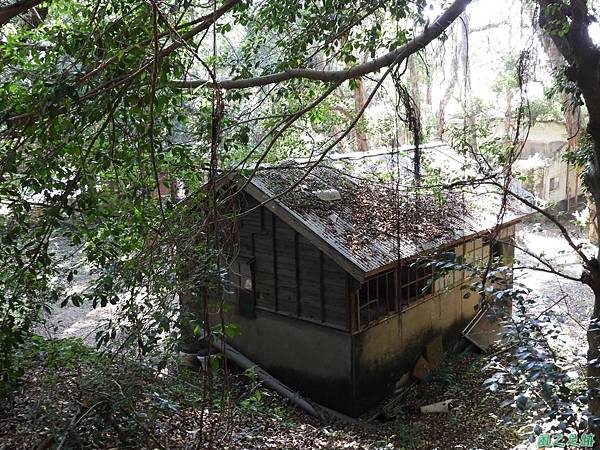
top-left (237, 143), bottom-right (532, 280)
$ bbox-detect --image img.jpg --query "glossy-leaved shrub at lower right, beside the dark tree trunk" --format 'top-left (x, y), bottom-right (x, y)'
top-left (484, 291), bottom-right (589, 441)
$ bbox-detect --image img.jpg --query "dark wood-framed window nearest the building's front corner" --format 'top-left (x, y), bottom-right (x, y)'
top-left (358, 270), bottom-right (397, 328)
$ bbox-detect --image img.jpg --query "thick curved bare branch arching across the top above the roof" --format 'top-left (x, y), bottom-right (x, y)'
top-left (171, 0), bottom-right (471, 89)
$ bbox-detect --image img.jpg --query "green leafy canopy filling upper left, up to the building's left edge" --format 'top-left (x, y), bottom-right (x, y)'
top-left (0, 0), bottom-right (440, 385)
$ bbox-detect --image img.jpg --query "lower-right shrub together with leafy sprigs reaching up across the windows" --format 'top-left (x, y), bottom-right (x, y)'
top-left (429, 250), bottom-right (590, 442)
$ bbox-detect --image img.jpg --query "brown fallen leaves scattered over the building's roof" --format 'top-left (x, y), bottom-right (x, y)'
top-left (258, 163), bottom-right (469, 255)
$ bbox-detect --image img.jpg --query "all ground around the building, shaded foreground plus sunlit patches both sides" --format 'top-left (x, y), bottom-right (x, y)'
top-left (0, 217), bottom-right (594, 450)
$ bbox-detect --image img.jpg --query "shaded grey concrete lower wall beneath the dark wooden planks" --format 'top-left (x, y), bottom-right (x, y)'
top-left (229, 310), bottom-right (354, 414)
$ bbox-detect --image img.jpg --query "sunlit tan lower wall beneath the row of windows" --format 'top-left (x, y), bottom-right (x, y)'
top-left (352, 232), bottom-right (506, 413)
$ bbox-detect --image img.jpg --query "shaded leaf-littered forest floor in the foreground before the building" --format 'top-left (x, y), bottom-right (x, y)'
top-left (0, 338), bottom-right (519, 450)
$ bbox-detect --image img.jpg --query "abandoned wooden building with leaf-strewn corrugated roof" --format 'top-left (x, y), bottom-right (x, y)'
top-left (223, 143), bottom-right (527, 416)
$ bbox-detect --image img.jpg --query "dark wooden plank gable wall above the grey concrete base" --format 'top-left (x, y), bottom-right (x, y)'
top-left (238, 197), bottom-right (349, 330)
